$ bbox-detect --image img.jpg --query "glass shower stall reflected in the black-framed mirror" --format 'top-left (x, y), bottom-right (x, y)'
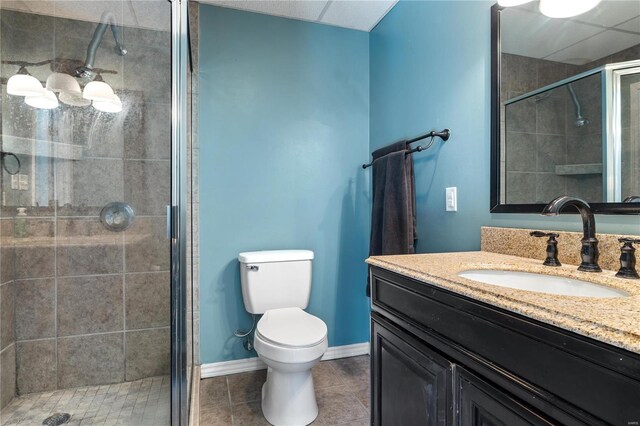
top-left (501, 60), bottom-right (640, 204)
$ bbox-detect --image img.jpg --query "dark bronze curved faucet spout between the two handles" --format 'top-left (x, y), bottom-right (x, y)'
top-left (542, 195), bottom-right (602, 272)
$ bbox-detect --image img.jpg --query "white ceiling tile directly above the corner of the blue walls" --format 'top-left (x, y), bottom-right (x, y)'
top-left (320, 0), bottom-right (397, 31)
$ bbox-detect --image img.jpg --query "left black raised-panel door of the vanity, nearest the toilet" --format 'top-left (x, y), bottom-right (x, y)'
top-left (371, 320), bottom-right (453, 426)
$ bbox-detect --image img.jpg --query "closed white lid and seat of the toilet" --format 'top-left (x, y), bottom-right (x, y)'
top-left (256, 308), bottom-right (327, 348)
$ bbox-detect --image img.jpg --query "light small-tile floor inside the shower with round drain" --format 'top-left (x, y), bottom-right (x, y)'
top-left (0, 376), bottom-right (170, 426)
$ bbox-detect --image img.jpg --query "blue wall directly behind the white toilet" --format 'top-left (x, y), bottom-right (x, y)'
top-left (199, 5), bottom-right (369, 363)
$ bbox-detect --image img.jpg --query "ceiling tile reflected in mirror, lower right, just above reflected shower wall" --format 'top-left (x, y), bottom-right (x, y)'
top-left (545, 30), bottom-right (640, 63)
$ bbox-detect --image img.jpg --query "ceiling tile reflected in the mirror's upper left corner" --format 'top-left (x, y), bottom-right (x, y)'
top-left (500, 8), bottom-right (602, 58)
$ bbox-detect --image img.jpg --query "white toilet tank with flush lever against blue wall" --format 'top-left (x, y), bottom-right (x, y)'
top-left (238, 250), bottom-right (313, 314)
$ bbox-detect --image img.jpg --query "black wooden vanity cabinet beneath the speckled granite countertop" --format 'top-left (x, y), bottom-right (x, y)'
top-left (370, 266), bottom-right (640, 426)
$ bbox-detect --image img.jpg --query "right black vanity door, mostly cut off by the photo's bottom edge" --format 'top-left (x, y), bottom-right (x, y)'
top-left (454, 365), bottom-right (553, 426)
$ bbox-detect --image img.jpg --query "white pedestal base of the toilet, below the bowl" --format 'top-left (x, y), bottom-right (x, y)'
top-left (262, 367), bottom-right (318, 426)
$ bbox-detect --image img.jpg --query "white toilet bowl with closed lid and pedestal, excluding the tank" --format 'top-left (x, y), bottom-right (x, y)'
top-left (253, 307), bottom-right (328, 426)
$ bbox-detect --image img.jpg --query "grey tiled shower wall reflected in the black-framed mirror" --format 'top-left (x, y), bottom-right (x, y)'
top-left (501, 46), bottom-right (640, 204)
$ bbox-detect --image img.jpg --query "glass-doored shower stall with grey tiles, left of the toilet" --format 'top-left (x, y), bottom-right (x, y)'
top-left (0, 0), bottom-right (193, 425)
